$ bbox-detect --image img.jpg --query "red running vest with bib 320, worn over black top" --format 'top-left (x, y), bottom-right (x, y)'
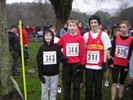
top-left (114, 34), bottom-right (132, 67)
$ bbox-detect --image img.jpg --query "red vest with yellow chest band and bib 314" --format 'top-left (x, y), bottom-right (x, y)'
top-left (86, 31), bottom-right (104, 66)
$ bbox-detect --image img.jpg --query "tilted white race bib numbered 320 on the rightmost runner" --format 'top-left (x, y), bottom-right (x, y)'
top-left (115, 45), bottom-right (129, 58)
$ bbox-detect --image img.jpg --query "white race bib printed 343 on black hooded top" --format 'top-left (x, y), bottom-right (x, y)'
top-left (43, 51), bottom-right (57, 65)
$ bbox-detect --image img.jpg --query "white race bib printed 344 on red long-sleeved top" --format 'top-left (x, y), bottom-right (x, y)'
top-left (66, 43), bottom-right (79, 56)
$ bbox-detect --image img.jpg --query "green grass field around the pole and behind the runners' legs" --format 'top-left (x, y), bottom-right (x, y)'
top-left (14, 42), bottom-right (131, 100)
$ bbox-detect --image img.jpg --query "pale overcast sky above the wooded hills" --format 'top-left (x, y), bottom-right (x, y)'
top-left (6, 0), bottom-right (133, 13)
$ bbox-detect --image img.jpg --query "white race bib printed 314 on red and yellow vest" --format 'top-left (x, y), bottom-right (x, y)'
top-left (86, 51), bottom-right (100, 64)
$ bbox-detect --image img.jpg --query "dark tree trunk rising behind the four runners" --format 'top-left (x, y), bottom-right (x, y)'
top-left (49, 0), bottom-right (73, 31)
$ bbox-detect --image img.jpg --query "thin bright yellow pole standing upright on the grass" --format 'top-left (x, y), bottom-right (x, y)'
top-left (19, 20), bottom-right (27, 100)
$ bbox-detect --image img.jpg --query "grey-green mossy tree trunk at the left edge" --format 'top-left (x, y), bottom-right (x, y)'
top-left (0, 0), bottom-right (12, 96)
